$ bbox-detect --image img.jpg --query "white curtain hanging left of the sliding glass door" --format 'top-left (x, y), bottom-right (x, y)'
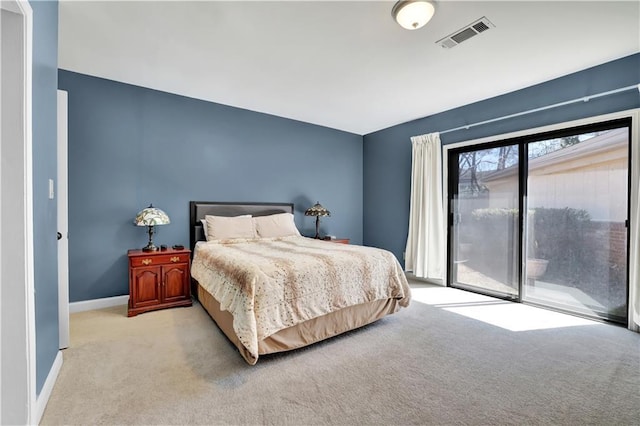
top-left (405, 133), bottom-right (445, 280)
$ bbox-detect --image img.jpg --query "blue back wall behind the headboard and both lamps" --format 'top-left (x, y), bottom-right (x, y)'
top-left (58, 70), bottom-right (363, 302)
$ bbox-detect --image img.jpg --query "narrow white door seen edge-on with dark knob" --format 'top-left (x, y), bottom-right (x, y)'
top-left (58, 90), bottom-right (69, 349)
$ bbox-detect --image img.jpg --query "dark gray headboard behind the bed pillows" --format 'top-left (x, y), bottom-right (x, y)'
top-left (189, 201), bottom-right (293, 250)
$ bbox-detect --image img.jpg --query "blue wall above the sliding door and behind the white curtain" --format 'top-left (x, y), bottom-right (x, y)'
top-left (363, 54), bottom-right (640, 259)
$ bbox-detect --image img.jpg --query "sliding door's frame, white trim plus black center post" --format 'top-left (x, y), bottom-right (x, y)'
top-left (442, 109), bottom-right (640, 331)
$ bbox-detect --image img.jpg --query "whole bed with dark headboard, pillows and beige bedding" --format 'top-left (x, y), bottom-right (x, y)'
top-left (189, 201), bottom-right (411, 365)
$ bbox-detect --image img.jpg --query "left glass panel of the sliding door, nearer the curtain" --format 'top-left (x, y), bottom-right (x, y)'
top-left (449, 145), bottom-right (520, 298)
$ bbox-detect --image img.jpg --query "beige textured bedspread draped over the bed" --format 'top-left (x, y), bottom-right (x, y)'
top-left (191, 237), bottom-right (410, 359)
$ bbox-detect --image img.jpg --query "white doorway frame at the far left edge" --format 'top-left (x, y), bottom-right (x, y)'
top-left (0, 0), bottom-right (37, 424)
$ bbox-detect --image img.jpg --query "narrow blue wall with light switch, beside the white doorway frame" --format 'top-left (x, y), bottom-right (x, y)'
top-left (30, 1), bottom-right (59, 393)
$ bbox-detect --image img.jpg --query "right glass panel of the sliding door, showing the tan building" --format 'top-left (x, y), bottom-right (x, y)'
top-left (522, 127), bottom-right (629, 322)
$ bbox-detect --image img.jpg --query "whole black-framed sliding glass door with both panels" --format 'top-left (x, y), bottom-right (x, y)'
top-left (448, 120), bottom-right (630, 323)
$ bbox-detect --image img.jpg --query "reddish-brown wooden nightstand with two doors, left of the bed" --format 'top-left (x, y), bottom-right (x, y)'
top-left (127, 249), bottom-right (191, 317)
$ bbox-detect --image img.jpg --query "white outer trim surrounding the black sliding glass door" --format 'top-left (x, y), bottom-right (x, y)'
top-left (442, 108), bottom-right (640, 331)
